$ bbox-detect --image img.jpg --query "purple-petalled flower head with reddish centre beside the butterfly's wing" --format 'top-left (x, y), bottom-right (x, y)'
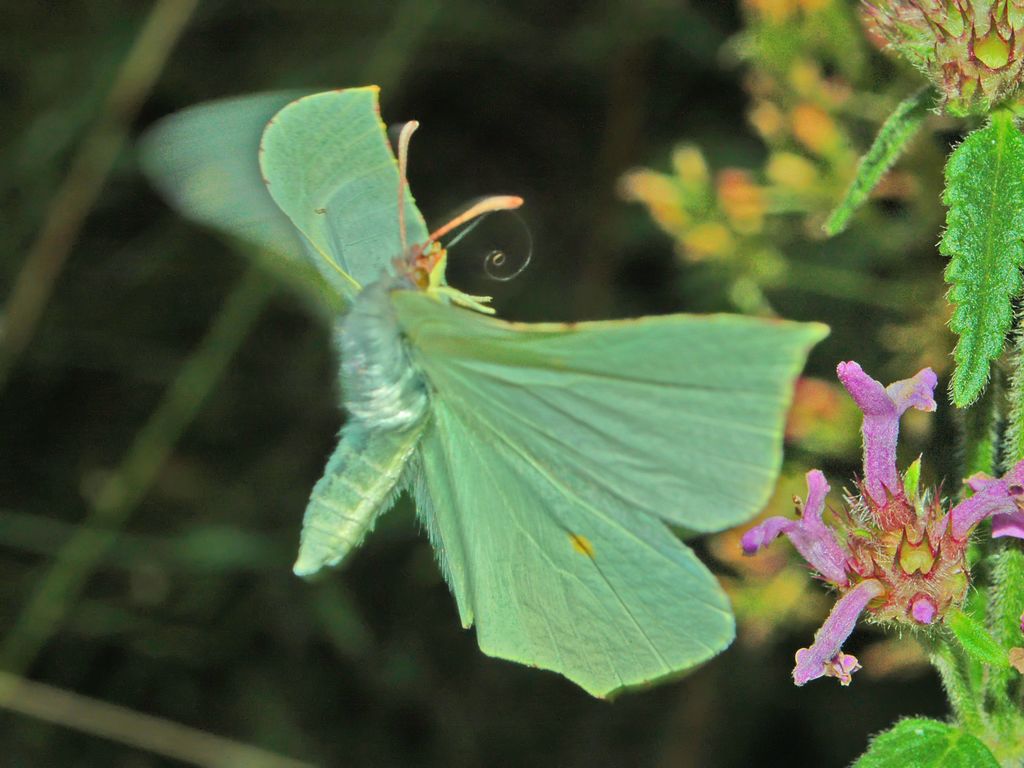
top-left (742, 362), bottom-right (1024, 685)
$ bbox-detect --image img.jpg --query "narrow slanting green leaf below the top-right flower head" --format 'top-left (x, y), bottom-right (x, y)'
top-left (823, 87), bottom-right (932, 237)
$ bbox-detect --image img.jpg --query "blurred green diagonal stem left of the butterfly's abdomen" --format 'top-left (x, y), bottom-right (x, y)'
top-left (0, 266), bottom-right (272, 674)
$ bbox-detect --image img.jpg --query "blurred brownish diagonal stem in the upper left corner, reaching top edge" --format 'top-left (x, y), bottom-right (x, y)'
top-left (0, 0), bottom-right (199, 391)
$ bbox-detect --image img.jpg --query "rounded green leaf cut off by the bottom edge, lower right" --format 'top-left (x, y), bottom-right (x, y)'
top-left (853, 718), bottom-right (999, 768)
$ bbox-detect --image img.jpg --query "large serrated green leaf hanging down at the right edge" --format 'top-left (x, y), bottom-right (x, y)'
top-left (939, 113), bottom-right (1024, 408)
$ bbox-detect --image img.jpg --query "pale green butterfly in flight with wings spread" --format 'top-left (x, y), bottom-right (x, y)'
top-left (143, 87), bottom-right (826, 696)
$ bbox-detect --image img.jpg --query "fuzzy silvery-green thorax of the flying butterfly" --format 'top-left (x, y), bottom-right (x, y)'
top-left (338, 275), bottom-right (427, 429)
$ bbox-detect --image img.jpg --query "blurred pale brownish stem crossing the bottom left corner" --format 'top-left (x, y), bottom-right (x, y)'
top-left (0, 672), bottom-right (311, 768)
